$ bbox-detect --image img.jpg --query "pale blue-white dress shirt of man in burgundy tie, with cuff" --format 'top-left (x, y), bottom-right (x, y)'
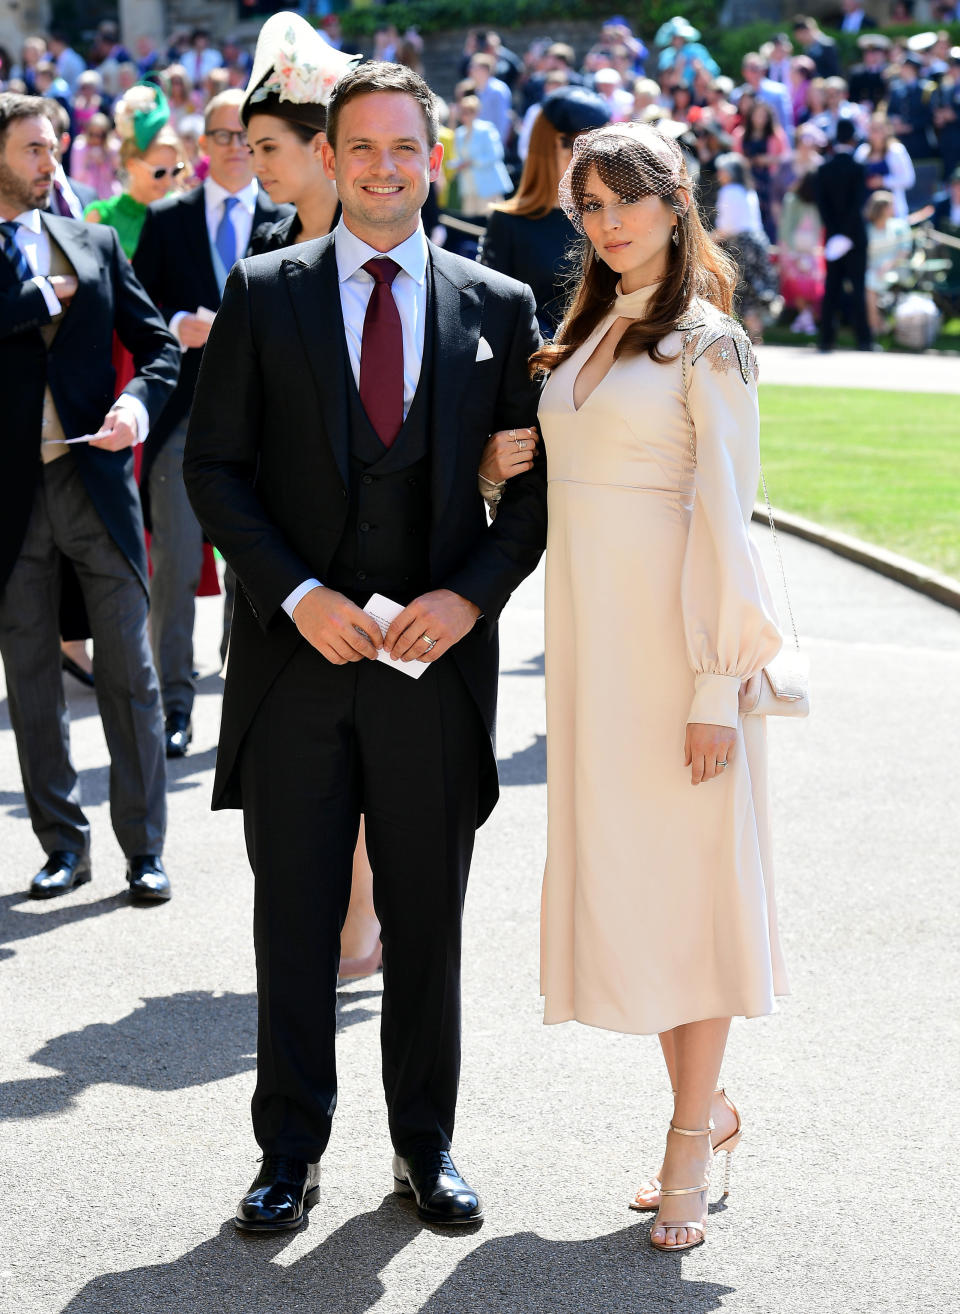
top-left (282, 219), bottom-right (428, 618)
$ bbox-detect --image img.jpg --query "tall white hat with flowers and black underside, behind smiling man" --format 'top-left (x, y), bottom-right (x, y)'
top-left (240, 11), bottom-right (361, 131)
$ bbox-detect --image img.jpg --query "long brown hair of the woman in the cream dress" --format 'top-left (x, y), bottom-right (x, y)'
top-left (529, 143), bottom-right (737, 374)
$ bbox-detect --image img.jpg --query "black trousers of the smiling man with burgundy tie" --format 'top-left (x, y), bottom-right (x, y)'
top-left (240, 643), bottom-right (483, 1162)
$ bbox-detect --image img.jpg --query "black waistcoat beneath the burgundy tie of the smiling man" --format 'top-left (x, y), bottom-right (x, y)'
top-left (327, 285), bottom-right (433, 606)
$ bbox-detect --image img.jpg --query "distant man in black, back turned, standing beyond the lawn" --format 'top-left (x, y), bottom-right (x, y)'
top-left (814, 118), bottom-right (872, 351)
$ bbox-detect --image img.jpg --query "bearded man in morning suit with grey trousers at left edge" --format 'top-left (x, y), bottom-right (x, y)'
top-left (0, 93), bottom-right (179, 900)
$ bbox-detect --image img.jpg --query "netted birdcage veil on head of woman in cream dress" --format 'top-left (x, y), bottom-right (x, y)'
top-left (559, 124), bottom-right (689, 233)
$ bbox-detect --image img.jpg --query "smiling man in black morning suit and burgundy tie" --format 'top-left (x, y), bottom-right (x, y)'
top-left (184, 62), bottom-right (546, 1231)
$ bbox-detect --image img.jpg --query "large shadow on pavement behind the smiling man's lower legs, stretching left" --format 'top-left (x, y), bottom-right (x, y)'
top-left (0, 989), bottom-right (381, 1120)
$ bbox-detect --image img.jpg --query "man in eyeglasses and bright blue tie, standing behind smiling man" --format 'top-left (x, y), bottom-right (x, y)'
top-left (134, 91), bottom-right (284, 757)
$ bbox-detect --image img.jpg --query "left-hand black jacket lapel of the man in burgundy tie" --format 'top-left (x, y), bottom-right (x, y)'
top-left (281, 237), bottom-right (349, 487)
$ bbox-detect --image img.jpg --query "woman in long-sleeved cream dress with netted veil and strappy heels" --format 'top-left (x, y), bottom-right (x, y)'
top-left (533, 124), bottom-right (785, 1250)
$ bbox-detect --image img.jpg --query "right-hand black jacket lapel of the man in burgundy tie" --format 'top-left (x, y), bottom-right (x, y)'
top-left (429, 243), bottom-right (485, 526)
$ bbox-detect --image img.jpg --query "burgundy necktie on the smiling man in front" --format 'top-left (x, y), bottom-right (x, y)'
top-left (360, 256), bottom-right (403, 447)
